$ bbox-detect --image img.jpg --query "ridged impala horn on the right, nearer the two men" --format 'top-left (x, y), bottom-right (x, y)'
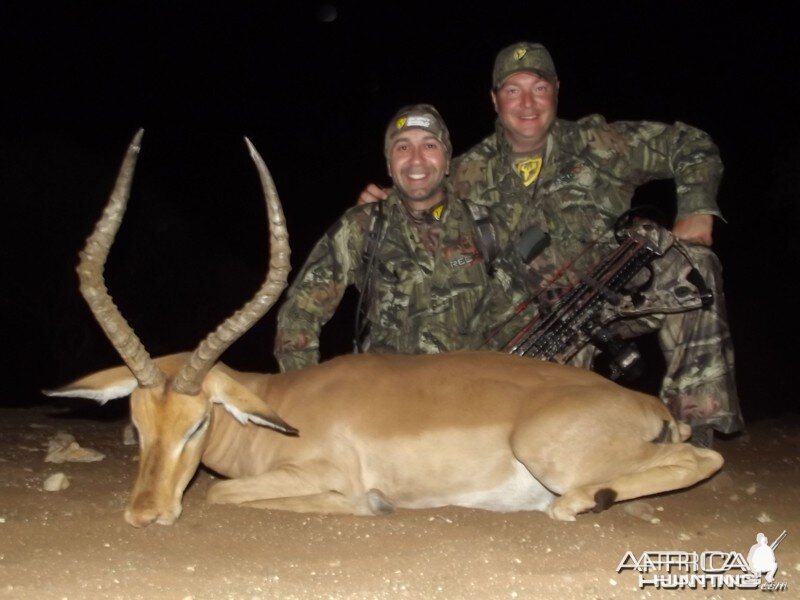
top-left (172, 138), bottom-right (290, 396)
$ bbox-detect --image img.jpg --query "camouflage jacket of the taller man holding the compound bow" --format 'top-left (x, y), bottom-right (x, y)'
top-left (452, 115), bottom-right (722, 291)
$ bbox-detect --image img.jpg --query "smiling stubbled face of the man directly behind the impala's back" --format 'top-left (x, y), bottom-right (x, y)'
top-left (389, 129), bottom-right (450, 210)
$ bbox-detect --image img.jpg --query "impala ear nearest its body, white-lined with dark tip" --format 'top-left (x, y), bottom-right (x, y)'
top-left (203, 369), bottom-right (299, 436)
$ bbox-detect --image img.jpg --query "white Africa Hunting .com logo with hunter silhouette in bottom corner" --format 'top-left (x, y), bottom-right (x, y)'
top-left (617, 531), bottom-right (788, 592)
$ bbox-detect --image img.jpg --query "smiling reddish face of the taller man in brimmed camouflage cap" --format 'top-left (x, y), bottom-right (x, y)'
top-left (492, 71), bottom-right (558, 152)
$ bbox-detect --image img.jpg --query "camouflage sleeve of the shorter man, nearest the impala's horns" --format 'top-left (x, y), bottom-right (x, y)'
top-left (274, 207), bottom-right (365, 372)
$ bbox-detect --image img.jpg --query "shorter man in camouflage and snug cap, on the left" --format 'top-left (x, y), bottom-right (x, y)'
top-left (275, 104), bottom-right (504, 371)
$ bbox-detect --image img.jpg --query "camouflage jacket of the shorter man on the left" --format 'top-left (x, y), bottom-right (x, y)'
top-left (275, 192), bottom-right (494, 371)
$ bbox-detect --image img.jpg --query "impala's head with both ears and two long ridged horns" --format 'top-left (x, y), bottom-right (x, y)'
top-left (45, 130), bottom-right (297, 527)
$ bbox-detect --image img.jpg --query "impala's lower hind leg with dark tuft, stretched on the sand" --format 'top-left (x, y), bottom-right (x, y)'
top-left (547, 443), bottom-right (723, 521)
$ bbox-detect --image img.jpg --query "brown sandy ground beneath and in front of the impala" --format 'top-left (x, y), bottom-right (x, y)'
top-left (0, 405), bottom-right (800, 600)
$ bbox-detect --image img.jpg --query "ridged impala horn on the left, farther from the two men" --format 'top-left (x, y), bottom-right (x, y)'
top-left (77, 129), bottom-right (165, 387)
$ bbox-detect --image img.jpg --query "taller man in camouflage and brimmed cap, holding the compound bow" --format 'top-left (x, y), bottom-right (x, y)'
top-left (460, 42), bottom-right (742, 434)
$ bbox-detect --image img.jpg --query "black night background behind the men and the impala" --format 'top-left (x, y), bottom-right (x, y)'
top-left (0, 0), bottom-right (800, 419)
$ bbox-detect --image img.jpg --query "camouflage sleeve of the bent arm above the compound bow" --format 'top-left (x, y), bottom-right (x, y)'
top-left (587, 117), bottom-right (723, 219)
